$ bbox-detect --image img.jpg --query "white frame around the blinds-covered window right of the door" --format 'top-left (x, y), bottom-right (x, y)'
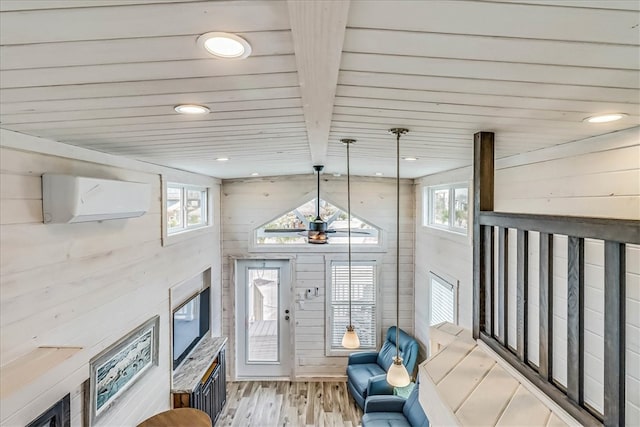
top-left (325, 254), bottom-right (382, 357)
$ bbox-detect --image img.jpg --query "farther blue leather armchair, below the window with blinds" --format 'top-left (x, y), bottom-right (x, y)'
top-left (347, 326), bottom-right (418, 408)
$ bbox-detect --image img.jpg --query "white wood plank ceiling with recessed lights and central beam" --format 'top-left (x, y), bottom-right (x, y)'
top-left (0, 0), bottom-right (640, 178)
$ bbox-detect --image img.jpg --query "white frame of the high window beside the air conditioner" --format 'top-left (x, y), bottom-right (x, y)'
top-left (162, 179), bottom-right (213, 246)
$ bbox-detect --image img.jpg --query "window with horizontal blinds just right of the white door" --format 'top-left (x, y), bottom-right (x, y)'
top-left (327, 261), bottom-right (378, 354)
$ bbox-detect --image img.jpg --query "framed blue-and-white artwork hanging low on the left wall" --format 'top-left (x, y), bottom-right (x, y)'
top-left (89, 316), bottom-right (160, 425)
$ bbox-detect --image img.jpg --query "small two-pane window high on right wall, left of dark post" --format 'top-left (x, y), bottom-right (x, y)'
top-left (423, 184), bottom-right (469, 234)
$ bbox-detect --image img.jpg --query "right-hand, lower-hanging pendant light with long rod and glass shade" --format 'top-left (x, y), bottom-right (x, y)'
top-left (387, 128), bottom-right (411, 387)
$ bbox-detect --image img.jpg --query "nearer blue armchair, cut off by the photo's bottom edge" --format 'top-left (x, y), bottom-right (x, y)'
top-left (362, 385), bottom-right (429, 427)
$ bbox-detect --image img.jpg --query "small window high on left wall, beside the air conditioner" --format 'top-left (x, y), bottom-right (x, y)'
top-left (166, 183), bottom-right (209, 235)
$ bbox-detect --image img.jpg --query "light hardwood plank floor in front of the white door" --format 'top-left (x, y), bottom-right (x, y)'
top-left (216, 381), bottom-right (362, 427)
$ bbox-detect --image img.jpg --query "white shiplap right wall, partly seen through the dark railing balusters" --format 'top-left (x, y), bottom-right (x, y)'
top-left (415, 128), bottom-right (640, 425)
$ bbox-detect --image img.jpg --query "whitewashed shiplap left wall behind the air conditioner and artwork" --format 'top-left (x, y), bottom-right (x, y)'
top-left (0, 131), bottom-right (221, 426)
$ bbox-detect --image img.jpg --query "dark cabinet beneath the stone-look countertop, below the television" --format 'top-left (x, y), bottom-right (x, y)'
top-left (173, 349), bottom-right (227, 424)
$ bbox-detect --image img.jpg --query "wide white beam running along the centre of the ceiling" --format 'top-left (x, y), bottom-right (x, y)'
top-left (288, 0), bottom-right (349, 165)
